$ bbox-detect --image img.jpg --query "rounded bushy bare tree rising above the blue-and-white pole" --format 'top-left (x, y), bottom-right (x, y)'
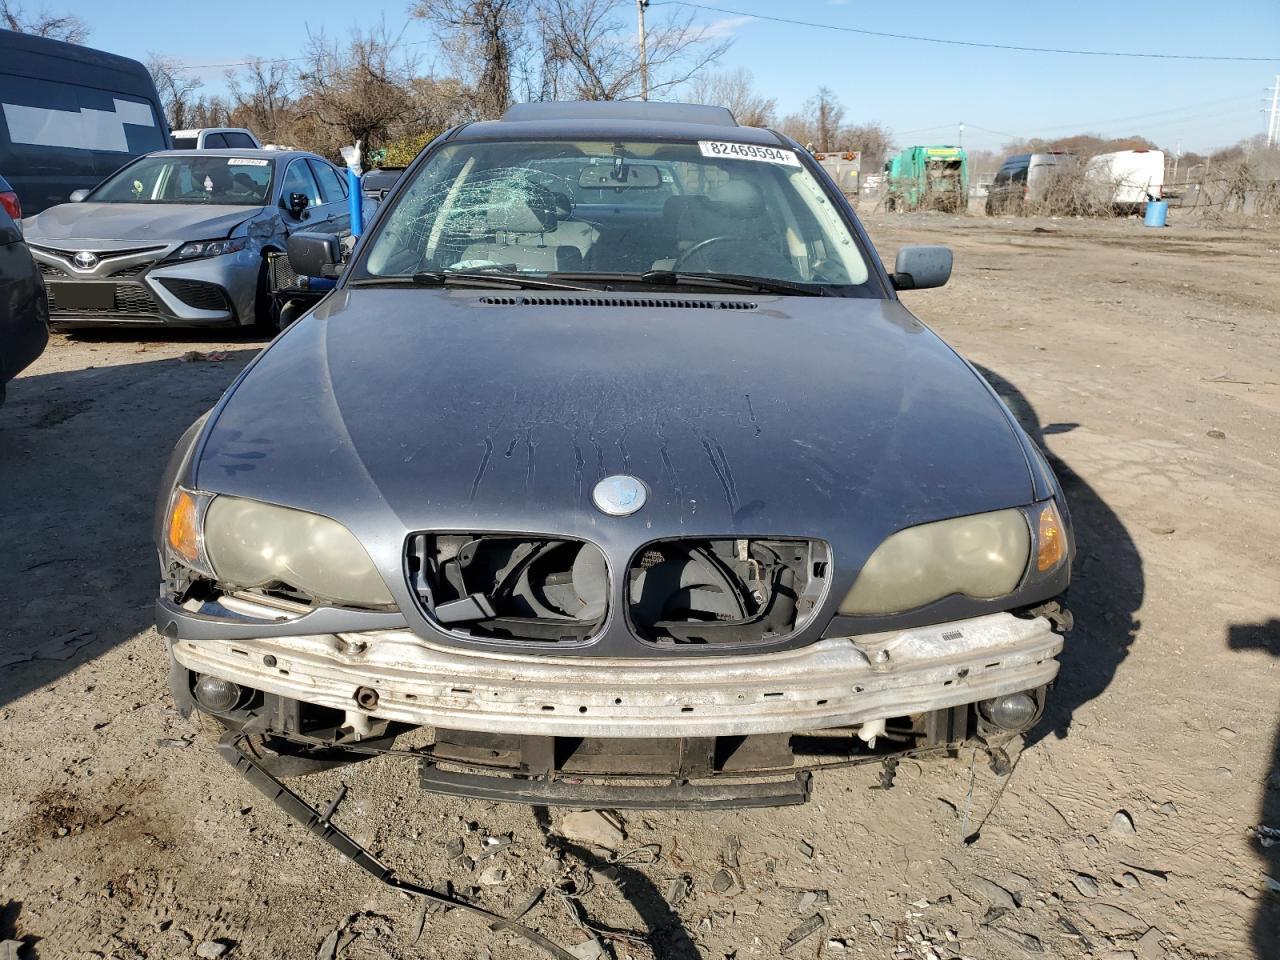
top-left (298, 23), bottom-right (417, 150)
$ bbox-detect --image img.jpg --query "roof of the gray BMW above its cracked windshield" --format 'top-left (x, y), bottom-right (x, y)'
top-left (453, 100), bottom-right (785, 146)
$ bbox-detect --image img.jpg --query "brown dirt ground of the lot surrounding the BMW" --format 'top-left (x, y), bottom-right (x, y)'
top-left (0, 215), bottom-right (1280, 960)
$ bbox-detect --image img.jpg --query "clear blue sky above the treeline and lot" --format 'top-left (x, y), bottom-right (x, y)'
top-left (62, 0), bottom-right (1280, 151)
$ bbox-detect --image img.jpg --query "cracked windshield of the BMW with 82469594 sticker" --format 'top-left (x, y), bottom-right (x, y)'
top-left (365, 141), bottom-right (868, 292)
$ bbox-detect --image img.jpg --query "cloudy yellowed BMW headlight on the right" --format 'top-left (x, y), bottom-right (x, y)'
top-left (840, 509), bottom-right (1034, 616)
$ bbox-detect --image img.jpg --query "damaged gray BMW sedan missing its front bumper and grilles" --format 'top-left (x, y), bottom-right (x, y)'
top-left (156, 102), bottom-right (1074, 814)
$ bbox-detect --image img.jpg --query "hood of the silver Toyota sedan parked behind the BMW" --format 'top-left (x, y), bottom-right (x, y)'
top-left (23, 204), bottom-right (262, 246)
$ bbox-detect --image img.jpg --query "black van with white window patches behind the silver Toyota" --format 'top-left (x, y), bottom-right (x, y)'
top-left (0, 29), bottom-right (169, 216)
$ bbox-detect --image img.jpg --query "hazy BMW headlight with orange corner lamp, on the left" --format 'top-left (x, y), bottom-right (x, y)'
top-left (165, 488), bottom-right (396, 607)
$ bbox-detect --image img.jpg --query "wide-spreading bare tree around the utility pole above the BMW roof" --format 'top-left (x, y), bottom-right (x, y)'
top-left (539, 0), bottom-right (730, 100)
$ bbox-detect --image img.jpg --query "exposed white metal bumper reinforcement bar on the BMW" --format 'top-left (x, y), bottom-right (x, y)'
top-left (170, 612), bottom-right (1062, 737)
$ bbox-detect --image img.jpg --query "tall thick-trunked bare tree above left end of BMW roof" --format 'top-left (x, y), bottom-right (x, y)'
top-left (412, 0), bottom-right (519, 118)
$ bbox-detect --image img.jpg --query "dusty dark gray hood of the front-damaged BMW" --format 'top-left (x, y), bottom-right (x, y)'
top-left (193, 288), bottom-right (1033, 558)
